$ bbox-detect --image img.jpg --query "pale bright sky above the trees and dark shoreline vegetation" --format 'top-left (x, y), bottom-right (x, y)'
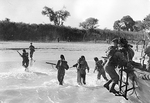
top-left (0, 0), bottom-right (150, 29)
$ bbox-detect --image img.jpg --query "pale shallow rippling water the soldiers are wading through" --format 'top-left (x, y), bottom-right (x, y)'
top-left (0, 42), bottom-right (144, 103)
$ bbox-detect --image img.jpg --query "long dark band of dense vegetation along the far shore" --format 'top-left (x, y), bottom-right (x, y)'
top-left (0, 20), bottom-right (143, 42)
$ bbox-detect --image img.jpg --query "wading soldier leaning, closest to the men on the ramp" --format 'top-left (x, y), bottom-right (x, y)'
top-left (93, 57), bottom-right (108, 81)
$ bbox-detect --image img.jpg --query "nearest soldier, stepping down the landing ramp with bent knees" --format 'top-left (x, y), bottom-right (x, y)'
top-left (104, 39), bottom-right (133, 93)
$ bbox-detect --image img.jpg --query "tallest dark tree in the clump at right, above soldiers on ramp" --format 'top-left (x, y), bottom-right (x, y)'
top-left (121, 15), bottom-right (135, 31)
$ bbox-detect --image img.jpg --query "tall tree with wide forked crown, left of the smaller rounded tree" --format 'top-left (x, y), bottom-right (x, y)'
top-left (42, 6), bottom-right (70, 26)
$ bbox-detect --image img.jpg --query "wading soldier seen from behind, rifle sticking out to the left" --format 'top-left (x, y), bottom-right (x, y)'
top-left (56, 55), bottom-right (69, 85)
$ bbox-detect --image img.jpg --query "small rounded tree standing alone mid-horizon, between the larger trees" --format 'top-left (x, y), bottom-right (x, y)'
top-left (79, 17), bottom-right (98, 30)
